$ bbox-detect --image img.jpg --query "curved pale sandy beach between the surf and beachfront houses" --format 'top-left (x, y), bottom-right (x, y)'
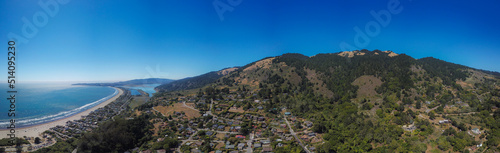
top-left (0, 88), bottom-right (123, 138)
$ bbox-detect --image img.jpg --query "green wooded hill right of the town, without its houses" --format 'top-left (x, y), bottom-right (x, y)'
top-left (197, 50), bottom-right (500, 152)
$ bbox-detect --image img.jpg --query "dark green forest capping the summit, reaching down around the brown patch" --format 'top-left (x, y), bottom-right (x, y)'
top-left (275, 50), bottom-right (416, 101)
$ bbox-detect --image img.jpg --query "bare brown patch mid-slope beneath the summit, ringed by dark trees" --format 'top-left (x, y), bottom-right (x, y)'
top-left (352, 75), bottom-right (382, 97)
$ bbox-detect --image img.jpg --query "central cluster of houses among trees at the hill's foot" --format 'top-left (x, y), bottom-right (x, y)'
top-left (136, 87), bottom-right (323, 153)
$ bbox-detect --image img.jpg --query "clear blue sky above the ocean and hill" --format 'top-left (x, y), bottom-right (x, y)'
top-left (0, 0), bottom-right (500, 82)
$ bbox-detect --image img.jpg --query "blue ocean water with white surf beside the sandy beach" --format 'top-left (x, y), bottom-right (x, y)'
top-left (0, 83), bottom-right (118, 129)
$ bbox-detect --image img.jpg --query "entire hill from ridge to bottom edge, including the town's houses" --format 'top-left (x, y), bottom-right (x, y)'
top-left (39, 50), bottom-right (500, 153)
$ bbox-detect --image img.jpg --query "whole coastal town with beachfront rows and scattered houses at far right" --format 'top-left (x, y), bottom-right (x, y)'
top-left (0, 83), bottom-right (494, 153)
